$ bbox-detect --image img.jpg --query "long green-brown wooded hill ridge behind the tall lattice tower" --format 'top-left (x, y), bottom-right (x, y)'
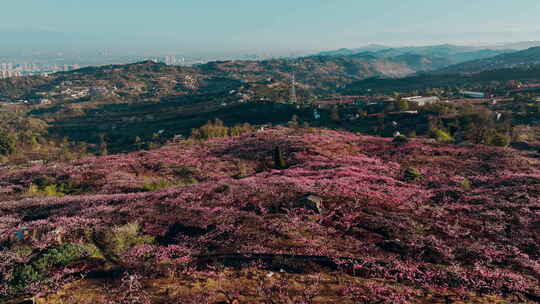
top-left (0, 56), bottom-right (430, 99)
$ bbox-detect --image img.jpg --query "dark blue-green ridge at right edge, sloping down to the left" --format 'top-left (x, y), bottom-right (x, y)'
top-left (437, 47), bottom-right (540, 74)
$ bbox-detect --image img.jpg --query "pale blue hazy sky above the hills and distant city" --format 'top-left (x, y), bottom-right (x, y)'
top-left (0, 0), bottom-right (540, 53)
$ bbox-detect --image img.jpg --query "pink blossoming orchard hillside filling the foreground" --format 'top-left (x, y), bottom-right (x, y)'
top-left (0, 128), bottom-right (540, 303)
